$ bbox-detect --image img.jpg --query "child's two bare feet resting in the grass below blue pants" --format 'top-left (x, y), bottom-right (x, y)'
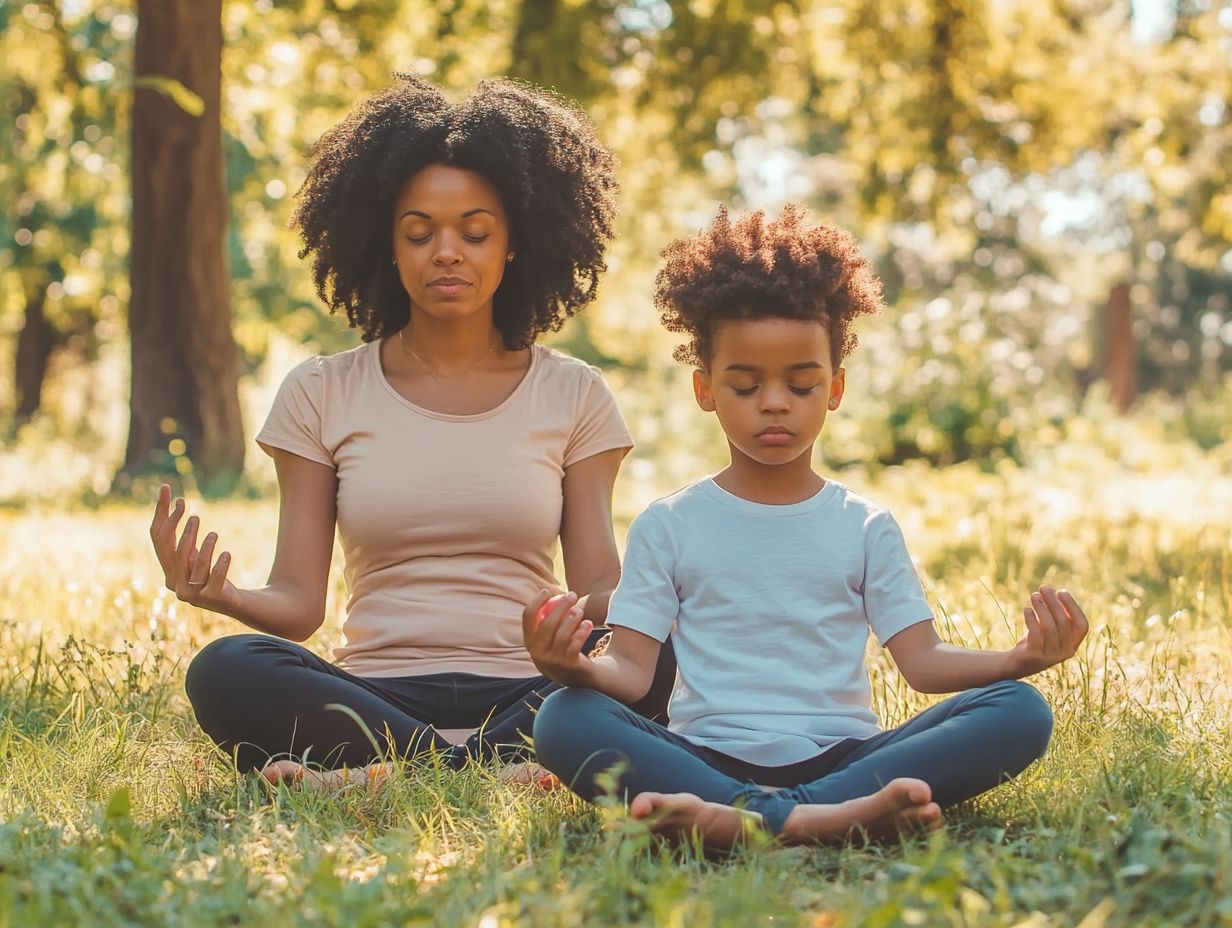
top-left (630, 779), bottom-right (941, 850)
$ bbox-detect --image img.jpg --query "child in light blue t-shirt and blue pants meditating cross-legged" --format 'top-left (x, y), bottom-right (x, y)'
top-left (522, 206), bottom-right (1088, 847)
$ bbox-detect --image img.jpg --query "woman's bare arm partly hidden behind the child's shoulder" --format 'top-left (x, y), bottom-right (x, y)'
top-left (561, 449), bottom-right (627, 625)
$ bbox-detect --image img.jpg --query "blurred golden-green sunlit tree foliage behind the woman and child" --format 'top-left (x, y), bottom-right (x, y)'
top-left (0, 0), bottom-right (1232, 497)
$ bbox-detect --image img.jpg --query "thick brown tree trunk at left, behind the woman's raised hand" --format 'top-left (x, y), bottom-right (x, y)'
top-left (122, 0), bottom-right (244, 490)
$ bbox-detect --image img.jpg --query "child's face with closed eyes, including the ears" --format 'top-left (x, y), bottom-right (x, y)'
top-left (694, 319), bottom-right (844, 465)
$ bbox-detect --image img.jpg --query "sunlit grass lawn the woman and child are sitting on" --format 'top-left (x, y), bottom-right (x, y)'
top-left (0, 458), bottom-right (1232, 928)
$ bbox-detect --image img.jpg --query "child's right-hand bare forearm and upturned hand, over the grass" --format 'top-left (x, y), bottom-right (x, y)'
top-left (886, 587), bottom-right (1089, 693)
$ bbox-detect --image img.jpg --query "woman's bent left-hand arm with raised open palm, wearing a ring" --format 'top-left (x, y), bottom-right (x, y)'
top-left (150, 450), bottom-right (338, 641)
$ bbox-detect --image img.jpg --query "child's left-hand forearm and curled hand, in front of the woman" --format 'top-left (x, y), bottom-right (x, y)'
top-left (522, 590), bottom-right (663, 704)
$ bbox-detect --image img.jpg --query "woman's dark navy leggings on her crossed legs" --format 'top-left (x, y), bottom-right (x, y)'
top-left (185, 630), bottom-right (675, 770)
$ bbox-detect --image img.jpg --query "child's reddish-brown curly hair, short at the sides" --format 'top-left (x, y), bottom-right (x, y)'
top-left (654, 203), bottom-right (882, 367)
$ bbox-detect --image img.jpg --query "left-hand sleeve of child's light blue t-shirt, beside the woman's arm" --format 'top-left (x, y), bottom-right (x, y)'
top-left (607, 511), bottom-right (680, 641)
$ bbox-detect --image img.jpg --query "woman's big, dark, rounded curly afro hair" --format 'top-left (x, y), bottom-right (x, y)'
top-left (291, 74), bottom-right (617, 349)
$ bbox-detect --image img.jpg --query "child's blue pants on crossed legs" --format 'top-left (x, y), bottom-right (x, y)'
top-left (535, 680), bottom-right (1052, 834)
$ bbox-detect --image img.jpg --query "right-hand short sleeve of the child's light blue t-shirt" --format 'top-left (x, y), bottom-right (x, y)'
top-left (864, 511), bottom-right (933, 647)
